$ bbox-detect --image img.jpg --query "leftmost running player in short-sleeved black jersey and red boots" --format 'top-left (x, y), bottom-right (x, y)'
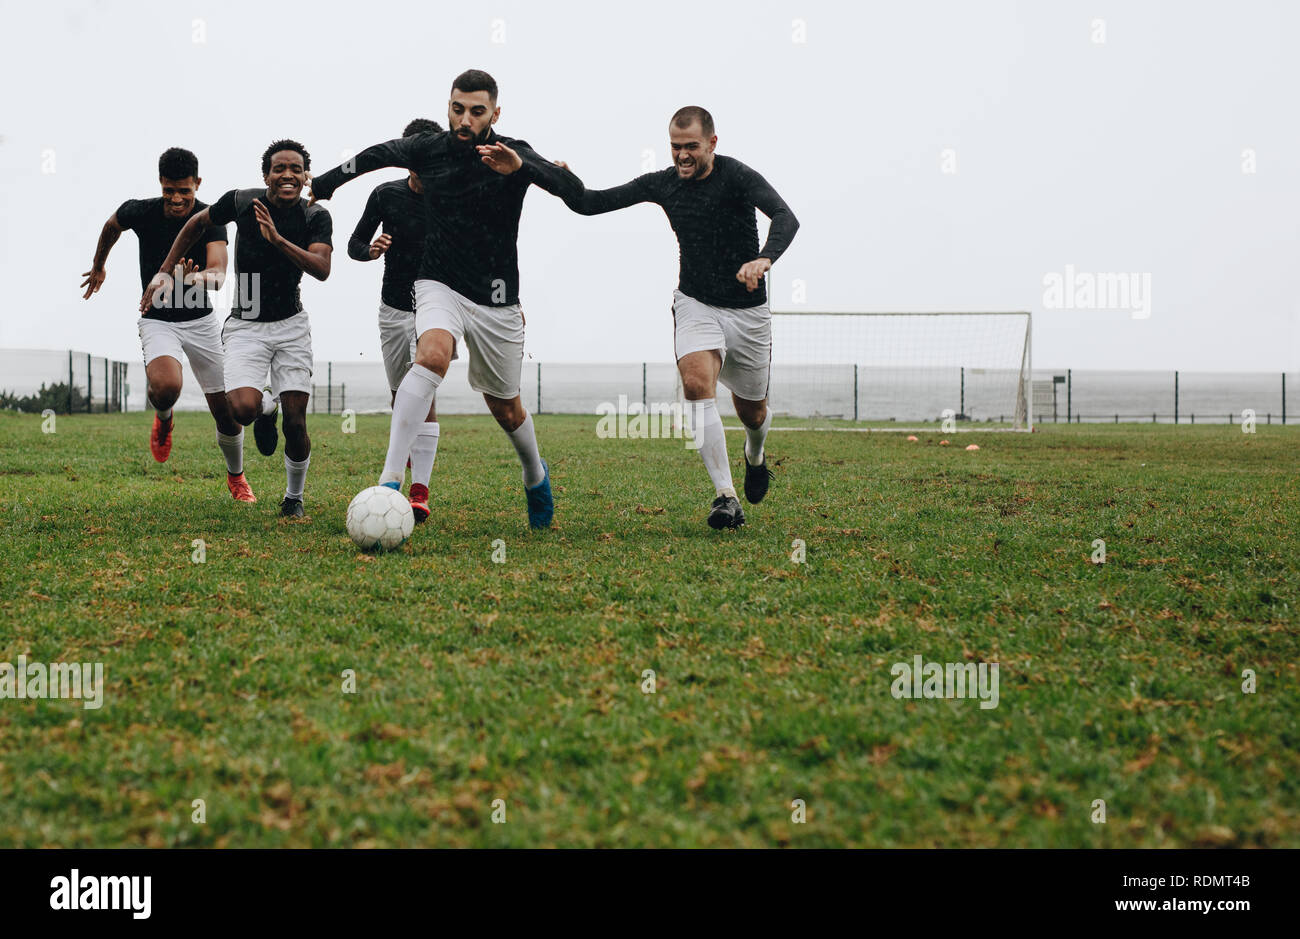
top-left (82, 147), bottom-right (257, 502)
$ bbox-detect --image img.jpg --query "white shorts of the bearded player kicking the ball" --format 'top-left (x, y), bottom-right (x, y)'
top-left (415, 280), bottom-right (524, 399)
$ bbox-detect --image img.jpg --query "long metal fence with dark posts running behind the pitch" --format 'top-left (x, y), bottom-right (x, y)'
top-left (0, 349), bottom-right (1300, 424)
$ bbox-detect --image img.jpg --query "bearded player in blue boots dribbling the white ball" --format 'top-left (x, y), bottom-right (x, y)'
top-left (312, 69), bottom-right (581, 528)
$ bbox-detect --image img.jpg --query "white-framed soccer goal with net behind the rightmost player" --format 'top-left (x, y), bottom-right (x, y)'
top-left (770, 312), bottom-right (1034, 430)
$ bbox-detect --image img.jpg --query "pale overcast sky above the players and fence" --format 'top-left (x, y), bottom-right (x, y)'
top-left (0, 0), bottom-right (1300, 371)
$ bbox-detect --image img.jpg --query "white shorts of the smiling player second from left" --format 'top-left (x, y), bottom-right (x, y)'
top-left (221, 313), bottom-right (312, 399)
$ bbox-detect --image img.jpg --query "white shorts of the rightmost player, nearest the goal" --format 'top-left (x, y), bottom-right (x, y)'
top-left (672, 290), bottom-right (772, 401)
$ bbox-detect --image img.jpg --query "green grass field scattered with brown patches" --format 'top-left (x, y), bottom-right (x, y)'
top-left (0, 414), bottom-right (1300, 847)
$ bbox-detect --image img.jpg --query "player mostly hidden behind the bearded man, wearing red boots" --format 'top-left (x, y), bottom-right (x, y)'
top-left (347, 117), bottom-right (442, 523)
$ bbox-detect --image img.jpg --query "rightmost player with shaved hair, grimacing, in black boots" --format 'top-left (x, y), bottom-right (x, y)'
top-left (560, 107), bottom-right (800, 528)
